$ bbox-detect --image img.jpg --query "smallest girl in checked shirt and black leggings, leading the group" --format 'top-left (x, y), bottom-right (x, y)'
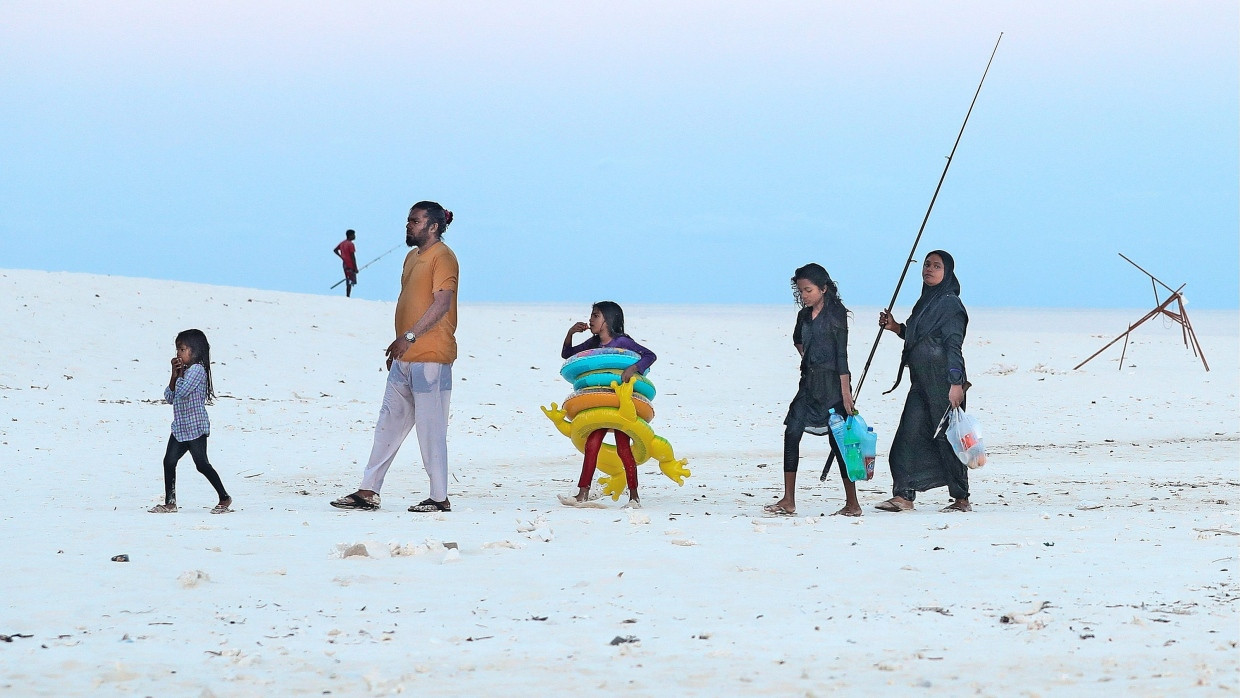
top-left (150, 330), bottom-right (232, 513)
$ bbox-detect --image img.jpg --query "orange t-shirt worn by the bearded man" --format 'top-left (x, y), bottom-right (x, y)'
top-left (396, 242), bottom-right (460, 363)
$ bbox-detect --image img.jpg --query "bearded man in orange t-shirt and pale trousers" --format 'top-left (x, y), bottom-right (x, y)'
top-left (331, 201), bottom-right (459, 512)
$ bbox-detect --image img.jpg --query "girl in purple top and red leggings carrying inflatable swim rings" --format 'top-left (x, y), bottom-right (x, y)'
top-left (559, 300), bottom-right (657, 508)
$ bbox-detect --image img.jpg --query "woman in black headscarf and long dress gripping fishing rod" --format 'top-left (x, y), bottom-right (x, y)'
top-left (877, 249), bottom-right (972, 512)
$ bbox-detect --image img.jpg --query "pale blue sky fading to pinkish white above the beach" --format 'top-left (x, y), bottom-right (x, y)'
top-left (0, 0), bottom-right (1240, 307)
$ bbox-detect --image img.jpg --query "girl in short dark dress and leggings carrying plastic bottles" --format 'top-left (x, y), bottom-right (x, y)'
top-left (763, 264), bottom-right (861, 516)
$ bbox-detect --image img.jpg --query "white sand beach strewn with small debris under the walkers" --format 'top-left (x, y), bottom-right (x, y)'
top-left (0, 270), bottom-right (1240, 697)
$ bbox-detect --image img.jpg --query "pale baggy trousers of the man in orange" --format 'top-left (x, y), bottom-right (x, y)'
top-left (361, 361), bottom-right (453, 502)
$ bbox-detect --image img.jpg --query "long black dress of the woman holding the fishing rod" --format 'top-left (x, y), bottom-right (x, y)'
top-left (889, 285), bottom-right (968, 501)
